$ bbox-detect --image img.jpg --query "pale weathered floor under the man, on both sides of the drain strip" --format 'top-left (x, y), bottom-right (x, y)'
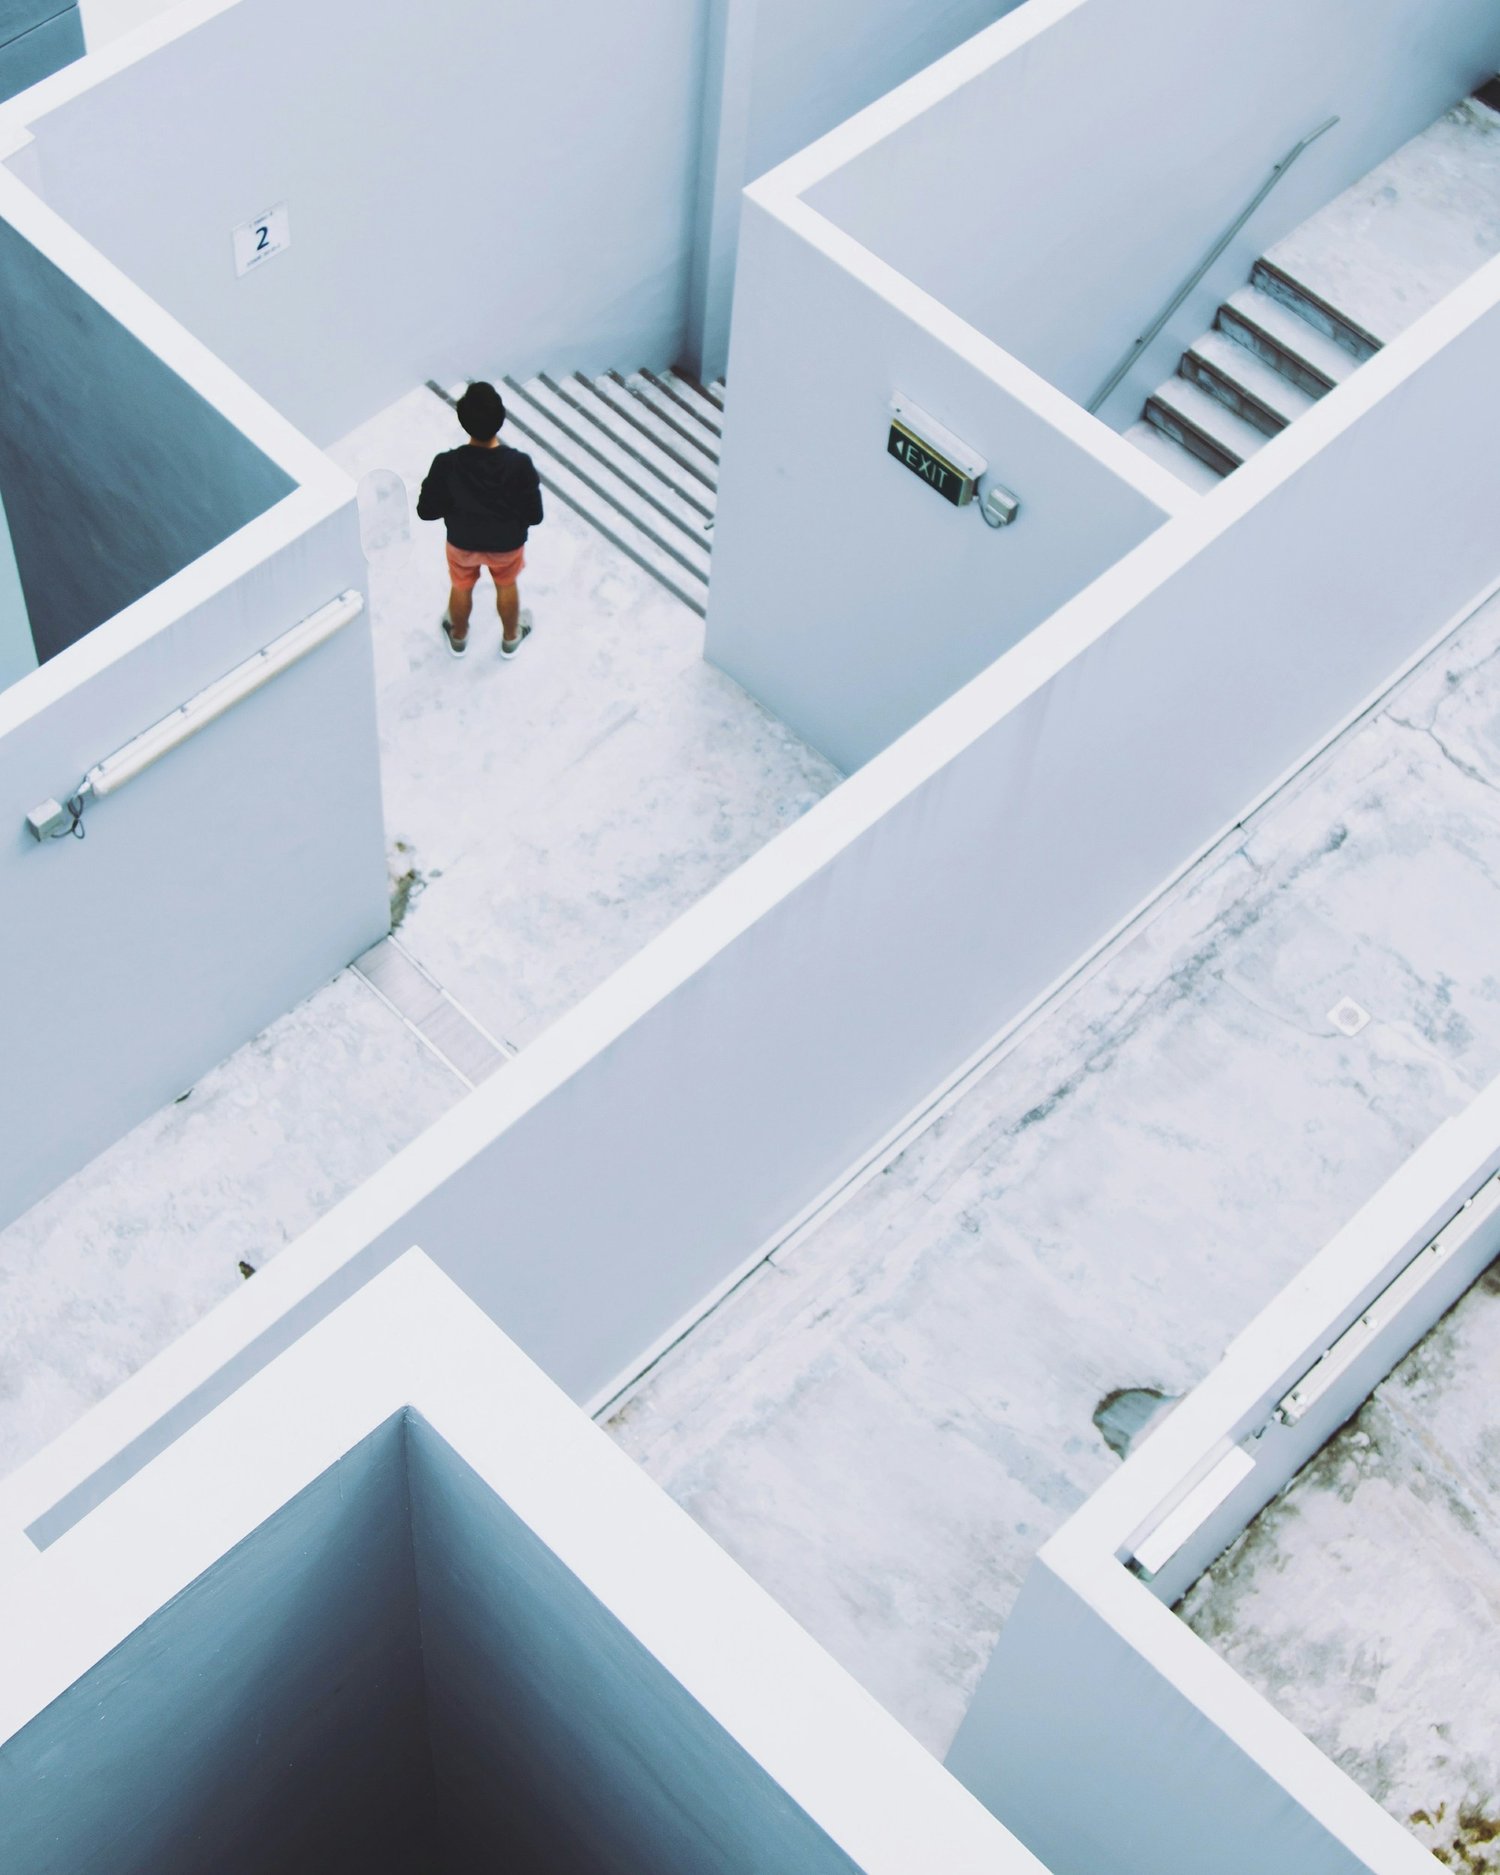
top-left (0, 390), bottom-right (836, 1474)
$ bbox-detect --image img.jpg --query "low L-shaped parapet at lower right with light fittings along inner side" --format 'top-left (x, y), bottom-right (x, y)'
top-left (947, 1084), bottom-right (1500, 1875)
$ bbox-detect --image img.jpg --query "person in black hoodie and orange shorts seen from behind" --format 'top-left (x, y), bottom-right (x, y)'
top-left (416, 383), bottom-right (542, 658)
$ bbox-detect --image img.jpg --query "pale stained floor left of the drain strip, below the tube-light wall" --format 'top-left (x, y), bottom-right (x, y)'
top-left (0, 971), bottom-right (465, 1474)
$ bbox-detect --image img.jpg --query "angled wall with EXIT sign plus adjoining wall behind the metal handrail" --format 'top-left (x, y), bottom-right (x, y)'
top-left (707, 0), bottom-right (1500, 771)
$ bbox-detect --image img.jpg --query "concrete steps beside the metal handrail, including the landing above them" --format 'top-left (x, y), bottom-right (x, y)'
top-left (1125, 94), bottom-right (1500, 489)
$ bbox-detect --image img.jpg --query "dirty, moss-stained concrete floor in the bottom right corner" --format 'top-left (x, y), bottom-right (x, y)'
top-left (1179, 1264), bottom-right (1500, 1875)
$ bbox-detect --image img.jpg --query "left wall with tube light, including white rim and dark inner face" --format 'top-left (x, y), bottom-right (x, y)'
top-left (0, 173), bottom-right (388, 1221)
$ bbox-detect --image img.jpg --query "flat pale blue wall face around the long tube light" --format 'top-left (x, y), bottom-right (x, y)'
top-left (0, 493), bottom-right (388, 1223)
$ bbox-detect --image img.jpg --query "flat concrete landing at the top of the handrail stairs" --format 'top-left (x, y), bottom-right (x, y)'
top-left (1266, 101), bottom-right (1500, 343)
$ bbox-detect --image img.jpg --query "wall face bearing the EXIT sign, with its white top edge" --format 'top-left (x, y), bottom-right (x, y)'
top-left (705, 192), bottom-right (1185, 771)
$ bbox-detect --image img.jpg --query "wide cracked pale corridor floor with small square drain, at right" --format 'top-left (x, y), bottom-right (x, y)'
top-left (611, 585), bottom-right (1500, 1751)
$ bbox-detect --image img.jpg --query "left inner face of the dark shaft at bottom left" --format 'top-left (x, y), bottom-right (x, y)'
top-left (0, 1418), bottom-right (431, 1875)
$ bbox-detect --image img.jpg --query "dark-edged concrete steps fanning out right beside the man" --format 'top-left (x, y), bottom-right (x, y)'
top-left (503, 369), bottom-right (724, 617)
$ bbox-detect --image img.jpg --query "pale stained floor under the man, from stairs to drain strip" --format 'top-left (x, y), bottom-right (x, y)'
top-left (332, 390), bottom-right (838, 1046)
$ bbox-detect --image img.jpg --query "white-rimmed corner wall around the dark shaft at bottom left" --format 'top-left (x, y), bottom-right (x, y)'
top-left (0, 1251), bottom-right (1044, 1875)
